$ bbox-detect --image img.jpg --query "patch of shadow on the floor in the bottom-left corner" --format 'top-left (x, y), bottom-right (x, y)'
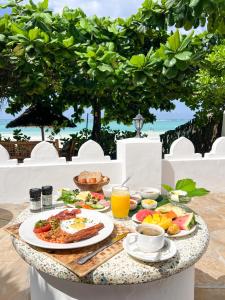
top-left (0, 272), bottom-right (30, 300)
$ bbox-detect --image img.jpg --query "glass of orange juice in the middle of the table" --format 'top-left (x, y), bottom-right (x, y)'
top-left (111, 186), bottom-right (130, 219)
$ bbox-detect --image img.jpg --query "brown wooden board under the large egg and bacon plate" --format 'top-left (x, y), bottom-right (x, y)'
top-left (5, 224), bottom-right (130, 277)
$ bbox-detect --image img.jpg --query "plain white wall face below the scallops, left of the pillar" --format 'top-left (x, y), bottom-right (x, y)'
top-left (0, 161), bottom-right (122, 203)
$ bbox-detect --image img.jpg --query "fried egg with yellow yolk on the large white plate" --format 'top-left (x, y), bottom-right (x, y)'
top-left (60, 217), bottom-right (95, 234)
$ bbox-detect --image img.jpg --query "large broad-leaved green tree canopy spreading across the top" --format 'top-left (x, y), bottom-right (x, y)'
top-left (0, 0), bottom-right (225, 140)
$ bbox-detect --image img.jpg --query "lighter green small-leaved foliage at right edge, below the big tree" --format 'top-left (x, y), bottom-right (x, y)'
top-left (186, 41), bottom-right (225, 124)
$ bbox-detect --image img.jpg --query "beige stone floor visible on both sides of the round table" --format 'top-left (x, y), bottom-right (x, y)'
top-left (0, 194), bottom-right (225, 300)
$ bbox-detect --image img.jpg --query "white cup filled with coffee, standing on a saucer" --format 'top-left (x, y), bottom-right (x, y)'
top-left (129, 224), bottom-right (165, 252)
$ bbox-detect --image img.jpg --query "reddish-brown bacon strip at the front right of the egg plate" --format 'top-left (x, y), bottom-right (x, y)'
top-left (63, 223), bottom-right (104, 243)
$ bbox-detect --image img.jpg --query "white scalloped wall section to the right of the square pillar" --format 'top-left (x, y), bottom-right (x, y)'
top-left (162, 137), bottom-right (225, 192)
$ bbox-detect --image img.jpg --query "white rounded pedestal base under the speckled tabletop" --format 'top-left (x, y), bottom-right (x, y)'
top-left (30, 266), bottom-right (194, 300)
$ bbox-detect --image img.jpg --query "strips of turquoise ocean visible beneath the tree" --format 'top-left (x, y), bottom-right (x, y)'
top-left (0, 119), bottom-right (189, 140)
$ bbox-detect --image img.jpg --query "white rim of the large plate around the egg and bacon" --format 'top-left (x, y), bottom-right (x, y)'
top-left (19, 209), bottom-right (114, 249)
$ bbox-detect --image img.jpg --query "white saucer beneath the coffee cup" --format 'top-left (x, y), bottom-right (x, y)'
top-left (123, 233), bottom-right (177, 262)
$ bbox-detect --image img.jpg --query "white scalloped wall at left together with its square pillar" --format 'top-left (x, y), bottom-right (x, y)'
top-left (0, 139), bottom-right (161, 202)
